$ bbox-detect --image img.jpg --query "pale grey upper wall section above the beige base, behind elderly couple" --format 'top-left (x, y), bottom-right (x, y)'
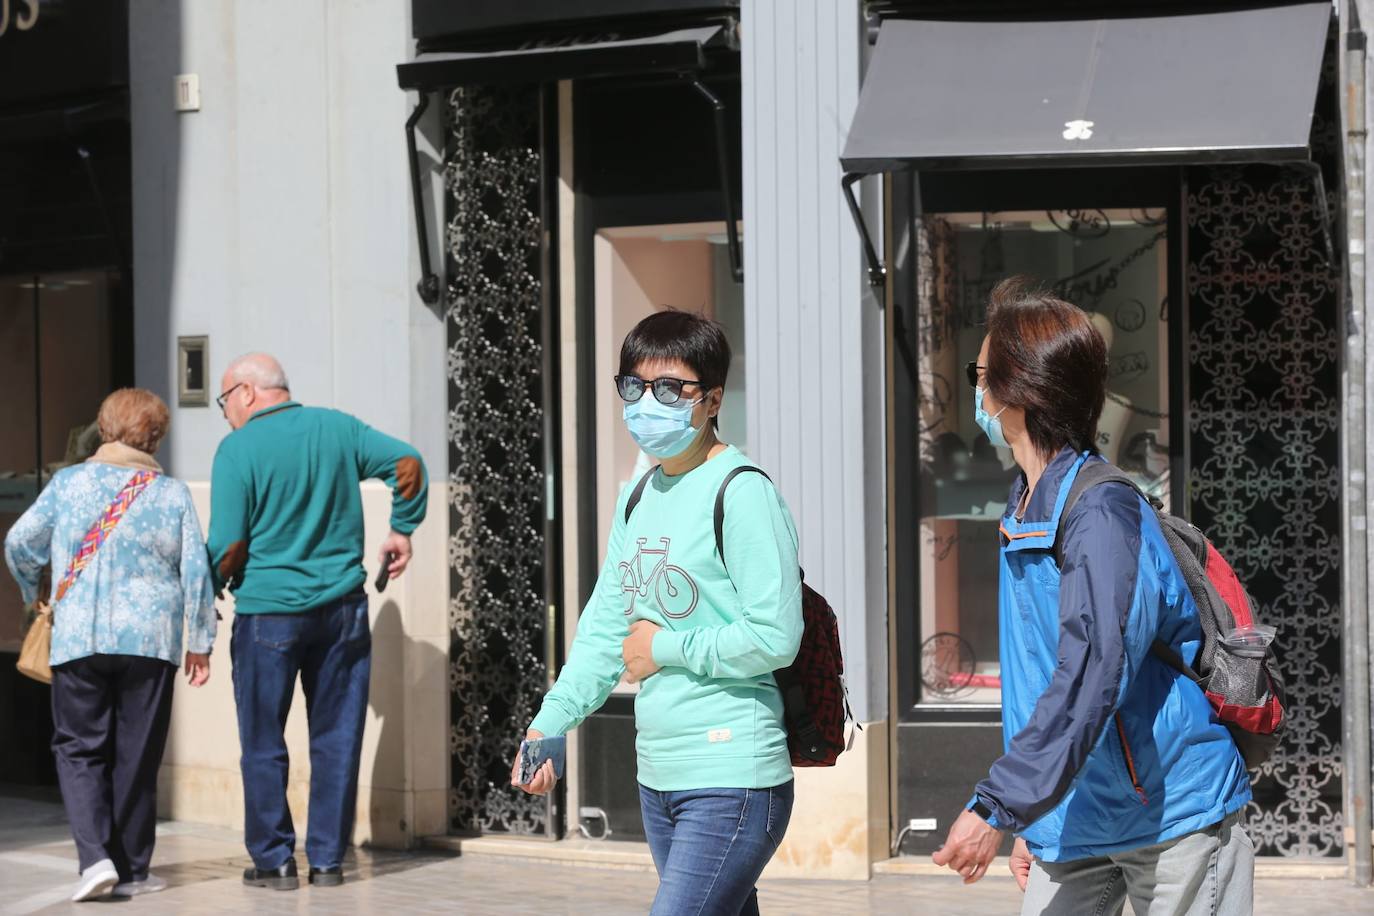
top-left (129, 0), bottom-right (447, 479)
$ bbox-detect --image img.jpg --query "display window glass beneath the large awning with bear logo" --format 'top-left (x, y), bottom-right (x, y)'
top-left (907, 210), bottom-right (1169, 705)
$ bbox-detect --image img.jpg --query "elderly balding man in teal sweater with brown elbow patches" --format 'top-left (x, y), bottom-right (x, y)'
top-left (209, 353), bottom-right (427, 890)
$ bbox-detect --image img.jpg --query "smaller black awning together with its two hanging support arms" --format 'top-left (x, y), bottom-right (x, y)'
top-left (396, 25), bottom-right (745, 305)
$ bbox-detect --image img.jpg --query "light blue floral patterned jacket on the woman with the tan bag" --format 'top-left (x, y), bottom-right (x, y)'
top-left (4, 458), bottom-right (216, 666)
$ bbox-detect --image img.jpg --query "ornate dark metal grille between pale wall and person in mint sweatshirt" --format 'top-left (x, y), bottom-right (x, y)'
top-left (445, 87), bottom-right (550, 834)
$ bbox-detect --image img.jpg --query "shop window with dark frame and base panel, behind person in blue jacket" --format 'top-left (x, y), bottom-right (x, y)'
top-left (892, 168), bottom-right (1182, 854)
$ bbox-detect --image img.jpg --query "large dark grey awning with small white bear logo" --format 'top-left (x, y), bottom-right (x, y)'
top-left (841, 0), bottom-right (1331, 173)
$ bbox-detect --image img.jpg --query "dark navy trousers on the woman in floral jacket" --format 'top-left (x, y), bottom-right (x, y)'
top-left (52, 655), bottom-right (176, 882)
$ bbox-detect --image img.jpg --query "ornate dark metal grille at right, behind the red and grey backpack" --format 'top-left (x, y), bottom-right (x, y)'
top-left (1187, 152), bottom-right (1341, 856)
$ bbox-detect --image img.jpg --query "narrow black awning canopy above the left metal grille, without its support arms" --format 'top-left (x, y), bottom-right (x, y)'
top-left (396, 26), bottom-right (723, 91)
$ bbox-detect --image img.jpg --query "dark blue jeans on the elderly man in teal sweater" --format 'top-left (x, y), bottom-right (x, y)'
top-left (229, 592), bottom-right (372, 868)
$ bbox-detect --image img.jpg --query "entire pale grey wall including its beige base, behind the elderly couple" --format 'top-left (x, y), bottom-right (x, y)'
top-left (129, 0), bottom-right (449, 846)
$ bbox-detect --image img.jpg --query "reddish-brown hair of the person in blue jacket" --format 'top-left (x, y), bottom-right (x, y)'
top-left (988, 276), bottom-right (1107, 457)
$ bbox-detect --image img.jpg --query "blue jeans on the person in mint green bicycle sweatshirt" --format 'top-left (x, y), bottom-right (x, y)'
top-left (639, 780), bottom-right (793, 916)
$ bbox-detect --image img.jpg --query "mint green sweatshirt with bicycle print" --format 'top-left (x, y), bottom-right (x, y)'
top-left (530, 446), bottom-right (802, 791)
